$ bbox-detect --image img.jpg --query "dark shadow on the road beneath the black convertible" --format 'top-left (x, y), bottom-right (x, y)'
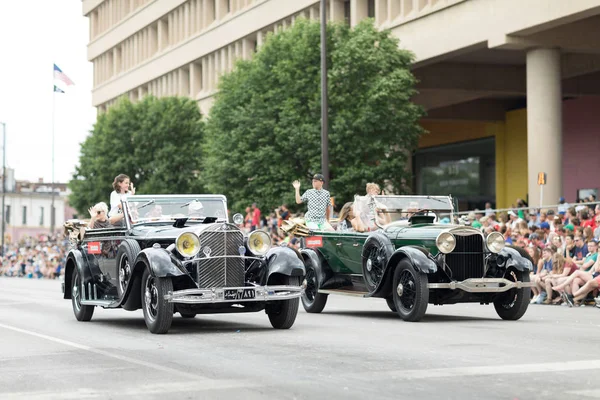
top-left (91, 315), bottom-right (273, 335)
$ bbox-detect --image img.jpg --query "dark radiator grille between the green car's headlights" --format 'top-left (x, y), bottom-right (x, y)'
top-left (446, 234), bottom-right (485, 281)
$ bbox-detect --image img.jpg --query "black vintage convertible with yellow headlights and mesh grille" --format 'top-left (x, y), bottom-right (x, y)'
top-left (63, 195), bottom-right (305, 333)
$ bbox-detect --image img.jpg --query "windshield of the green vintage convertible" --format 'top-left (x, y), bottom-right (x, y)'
top-left (353, 196), bottom-right (453, 226)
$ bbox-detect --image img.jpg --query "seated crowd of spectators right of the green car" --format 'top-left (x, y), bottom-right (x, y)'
top-left (463, 197), bottom-right (600, 307)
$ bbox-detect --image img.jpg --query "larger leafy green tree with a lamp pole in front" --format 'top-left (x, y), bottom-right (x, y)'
top-left (204, 20), bottom-right (423, 210)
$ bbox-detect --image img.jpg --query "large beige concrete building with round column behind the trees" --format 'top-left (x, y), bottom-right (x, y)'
top-left (82, 0), bottom-right (600, 208)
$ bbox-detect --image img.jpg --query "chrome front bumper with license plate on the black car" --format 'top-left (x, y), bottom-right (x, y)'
top-left (165, 285), bottom-right (304, 304)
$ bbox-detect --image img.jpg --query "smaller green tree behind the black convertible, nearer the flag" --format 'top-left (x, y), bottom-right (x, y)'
top-left (69, 96), bottom-right (205, 213)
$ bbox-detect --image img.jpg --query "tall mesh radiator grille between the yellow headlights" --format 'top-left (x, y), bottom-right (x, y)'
top-left (198, 224), bottom-right (244, 288)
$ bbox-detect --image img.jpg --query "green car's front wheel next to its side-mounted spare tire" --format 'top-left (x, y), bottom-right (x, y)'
top-left (392, 259), bottom-right (429, 321)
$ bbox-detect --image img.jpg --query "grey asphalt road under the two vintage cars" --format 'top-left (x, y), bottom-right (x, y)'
top-left (0, 278), bottom-right (600, 400)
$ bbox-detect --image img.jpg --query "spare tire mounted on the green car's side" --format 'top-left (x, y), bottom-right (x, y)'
top-left (362, 234), bottom-right (394, 293)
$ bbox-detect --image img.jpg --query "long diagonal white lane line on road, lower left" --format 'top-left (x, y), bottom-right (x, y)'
top-left (0, 324), bottom-right (253, 387)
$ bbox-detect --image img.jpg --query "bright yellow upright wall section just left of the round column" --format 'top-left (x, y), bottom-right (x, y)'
top-left (496, 109), bottom-right (527, 208)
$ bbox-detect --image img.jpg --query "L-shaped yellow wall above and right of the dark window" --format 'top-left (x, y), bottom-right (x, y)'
top-left (419, 109), bottom-right (527, 208)
